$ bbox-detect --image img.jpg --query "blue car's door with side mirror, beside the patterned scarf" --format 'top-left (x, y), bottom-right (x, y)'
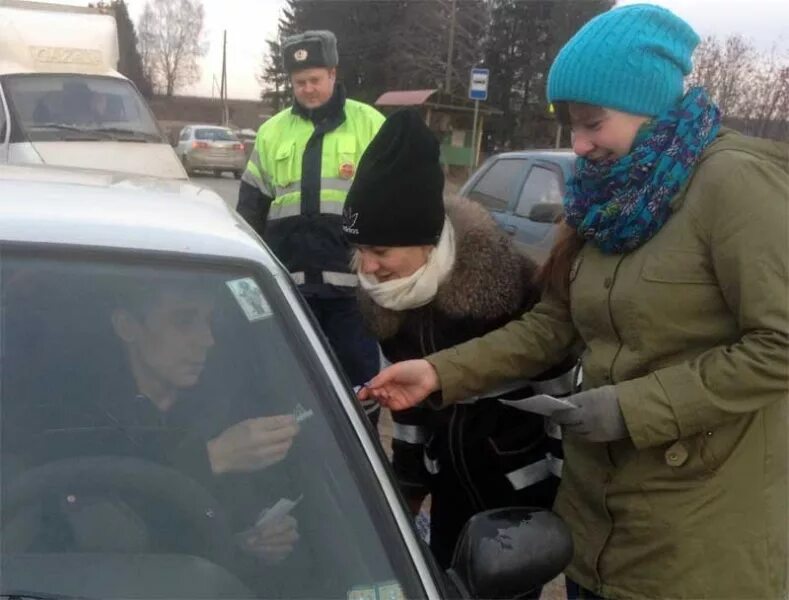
top-left (510, 160), bottom-right (564, 262)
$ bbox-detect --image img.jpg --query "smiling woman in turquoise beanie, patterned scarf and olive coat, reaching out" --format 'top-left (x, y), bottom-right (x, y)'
top-left (361, 4), bottom-right (789, 599)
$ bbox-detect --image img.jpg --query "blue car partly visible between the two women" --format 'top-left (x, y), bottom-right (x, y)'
top-left (459, 150), bottom-right (576, 262)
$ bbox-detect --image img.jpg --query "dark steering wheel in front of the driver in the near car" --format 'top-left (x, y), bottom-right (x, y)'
top-left (1, 456), bottom-right (233, 564)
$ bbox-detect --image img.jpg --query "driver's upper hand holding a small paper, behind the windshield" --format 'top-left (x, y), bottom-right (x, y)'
top-left (207, 414), bottom-right (299, 474)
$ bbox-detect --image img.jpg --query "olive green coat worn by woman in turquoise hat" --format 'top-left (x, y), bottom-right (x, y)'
top-left (428, 131), bottom-right (789, 599)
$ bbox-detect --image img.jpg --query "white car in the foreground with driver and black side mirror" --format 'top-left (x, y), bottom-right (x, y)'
top-left (0, 167), bottom-right (572, 600)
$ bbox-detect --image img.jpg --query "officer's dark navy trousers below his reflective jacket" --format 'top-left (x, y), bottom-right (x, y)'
top-left (307, 296), bottom-right (380, 424)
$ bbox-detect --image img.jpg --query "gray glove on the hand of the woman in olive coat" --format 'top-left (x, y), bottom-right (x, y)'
top-left (551, 385), bottom-right (630, 442)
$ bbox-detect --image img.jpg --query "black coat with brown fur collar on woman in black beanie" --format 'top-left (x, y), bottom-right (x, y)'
top-left (359, 199), bottom-right (574, 567)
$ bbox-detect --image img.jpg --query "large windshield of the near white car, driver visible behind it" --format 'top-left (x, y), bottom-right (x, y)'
top-left (0, 247), bottom-right (424, 600)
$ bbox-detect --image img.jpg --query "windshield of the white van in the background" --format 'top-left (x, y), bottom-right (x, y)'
top-left (3, 74), bottom-right (161, 142)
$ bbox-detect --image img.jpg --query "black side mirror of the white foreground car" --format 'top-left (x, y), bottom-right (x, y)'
top-left (447, 507), bottom-right (573, 598)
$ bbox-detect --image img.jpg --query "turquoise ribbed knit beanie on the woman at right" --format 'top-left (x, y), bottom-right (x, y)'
top-left (548, 4), bottom-right (700, 116)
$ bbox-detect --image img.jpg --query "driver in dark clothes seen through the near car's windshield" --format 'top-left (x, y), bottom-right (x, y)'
top-left (5, 275), bottom-right (299, 564)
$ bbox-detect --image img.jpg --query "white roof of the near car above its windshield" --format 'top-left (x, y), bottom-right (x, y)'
top-left (0, 162), bottom-right (280, 272)
